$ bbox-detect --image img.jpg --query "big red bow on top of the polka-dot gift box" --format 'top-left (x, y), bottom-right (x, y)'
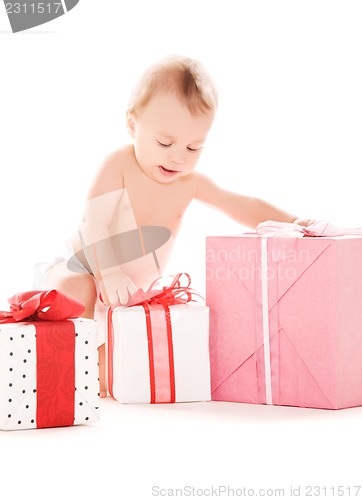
top-left (0, 290), bottom-right (85, 323)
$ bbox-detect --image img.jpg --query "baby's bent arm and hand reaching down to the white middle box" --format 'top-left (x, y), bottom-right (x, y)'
top-left (80, 151), bottom-right (137, 305)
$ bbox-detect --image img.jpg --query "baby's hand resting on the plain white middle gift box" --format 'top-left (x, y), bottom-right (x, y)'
top-left (99, 269), bottom-right (137, 306)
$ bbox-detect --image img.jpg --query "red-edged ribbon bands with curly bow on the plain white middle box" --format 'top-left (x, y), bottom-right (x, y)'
top-left (108, 273), bottom-right (200, 403)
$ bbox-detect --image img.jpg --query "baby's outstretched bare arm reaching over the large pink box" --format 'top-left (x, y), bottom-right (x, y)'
top-left (194, 173), bottom-right (309, 228)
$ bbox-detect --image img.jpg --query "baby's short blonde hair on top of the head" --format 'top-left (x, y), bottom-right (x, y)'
top-left (128, 55), bottom-right (218, 115)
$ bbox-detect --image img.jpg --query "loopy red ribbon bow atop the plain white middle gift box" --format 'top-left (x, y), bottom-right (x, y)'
top-left (127, 273), bottom-right (201, 307)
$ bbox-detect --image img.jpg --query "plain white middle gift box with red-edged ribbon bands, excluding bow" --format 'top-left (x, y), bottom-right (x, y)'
top-left (107, 303), bottom-right (211, 403)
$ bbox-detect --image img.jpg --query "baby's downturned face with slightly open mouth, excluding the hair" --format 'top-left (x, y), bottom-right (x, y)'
top-left (128, 93), bottom-right (214, 183)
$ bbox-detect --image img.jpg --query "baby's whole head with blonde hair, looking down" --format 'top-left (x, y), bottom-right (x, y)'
top-left (127, 56), bottom-right (217, 183)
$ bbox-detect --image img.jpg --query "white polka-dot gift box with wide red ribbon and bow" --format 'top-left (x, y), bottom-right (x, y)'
top-left (0, 290), bottom-right (99, 430)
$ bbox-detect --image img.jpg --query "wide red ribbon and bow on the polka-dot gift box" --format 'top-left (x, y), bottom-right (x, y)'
top-left (0, 290), bottom-right (85, 428)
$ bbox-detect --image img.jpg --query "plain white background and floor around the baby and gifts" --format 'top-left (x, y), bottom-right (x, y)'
top-left (0, 0), bottom-right (362, 499)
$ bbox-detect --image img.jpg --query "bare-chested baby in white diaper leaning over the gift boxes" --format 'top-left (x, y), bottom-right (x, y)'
top-left (46, 56), bottom-right (308, 397)
